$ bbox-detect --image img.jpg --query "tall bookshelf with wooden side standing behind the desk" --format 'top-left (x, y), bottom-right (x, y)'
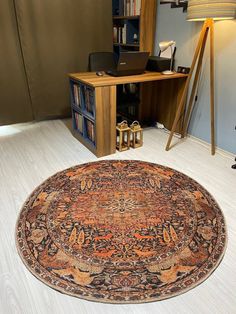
top-left (112, 0), bottom-right (157, 123)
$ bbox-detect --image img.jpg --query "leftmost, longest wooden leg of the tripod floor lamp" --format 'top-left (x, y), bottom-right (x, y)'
top-left (166, 20), bottom-right (209, 151)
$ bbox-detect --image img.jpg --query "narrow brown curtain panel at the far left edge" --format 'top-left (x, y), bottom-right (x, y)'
top-left (0, 0), bottom-right (33, 125)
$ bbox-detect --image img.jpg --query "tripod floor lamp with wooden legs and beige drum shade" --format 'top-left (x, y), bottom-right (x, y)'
top-left (166, 0), bottom-right (236, 155)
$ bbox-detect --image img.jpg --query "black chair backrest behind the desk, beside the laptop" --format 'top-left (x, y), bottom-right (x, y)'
top-left (89, 52), bottom-right (116, 72)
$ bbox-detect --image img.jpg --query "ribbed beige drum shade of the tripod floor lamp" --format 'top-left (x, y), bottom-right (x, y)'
top-left (187, 0), bottom-right (236, 21)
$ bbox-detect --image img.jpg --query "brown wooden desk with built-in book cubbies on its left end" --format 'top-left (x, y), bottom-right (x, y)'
top-left (69, 72), bottom-right (187, 157)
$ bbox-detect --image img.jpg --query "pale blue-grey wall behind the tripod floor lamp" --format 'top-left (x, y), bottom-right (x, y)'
top-left (155, 4), bottom-right (236, 153)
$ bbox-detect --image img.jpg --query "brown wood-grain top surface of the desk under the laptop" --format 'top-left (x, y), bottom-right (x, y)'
top-left (69, 72), bottom-right (188, 87)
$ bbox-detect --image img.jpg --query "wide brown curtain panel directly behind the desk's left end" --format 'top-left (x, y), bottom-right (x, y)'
top-left (0, 0), bottom-right (112, 125)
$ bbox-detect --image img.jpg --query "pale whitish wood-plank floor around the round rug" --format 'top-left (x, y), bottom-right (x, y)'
top-left (0, 120), bottom-right (236, 314)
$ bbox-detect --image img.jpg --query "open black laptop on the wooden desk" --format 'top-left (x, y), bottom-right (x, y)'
top-left (106, 51), bottom-right (149, 76)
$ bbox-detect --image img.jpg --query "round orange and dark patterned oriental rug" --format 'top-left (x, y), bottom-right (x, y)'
top-left (16, 160), bottom-right (226, 303)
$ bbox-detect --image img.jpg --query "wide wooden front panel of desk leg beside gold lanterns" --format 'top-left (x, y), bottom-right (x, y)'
top-left (95, 86), bottom-right (116, 157)
